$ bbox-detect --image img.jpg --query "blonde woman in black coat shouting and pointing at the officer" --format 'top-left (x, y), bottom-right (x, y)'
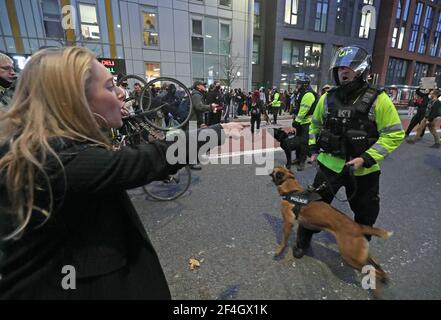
top-left (0, 47), bottom-right (243, 299)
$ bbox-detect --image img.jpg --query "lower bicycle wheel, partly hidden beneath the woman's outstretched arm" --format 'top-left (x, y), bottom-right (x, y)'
top-left (142, 166), bottom-right (191, 201)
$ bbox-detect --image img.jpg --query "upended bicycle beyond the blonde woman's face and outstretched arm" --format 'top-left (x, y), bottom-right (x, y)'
top-left (112, 75), bottom-right (193, 201)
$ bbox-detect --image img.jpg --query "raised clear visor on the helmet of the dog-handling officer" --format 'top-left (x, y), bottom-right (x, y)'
top-left (331, 47), bottom-right (370, 73)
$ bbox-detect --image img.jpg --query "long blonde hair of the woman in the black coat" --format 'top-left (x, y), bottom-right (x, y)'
top-left (0, 47), bottom-right (108, 240)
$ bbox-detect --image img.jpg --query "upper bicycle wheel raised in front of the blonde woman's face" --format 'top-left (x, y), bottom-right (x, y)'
top-left (140, 77), bottom-right (193, 131)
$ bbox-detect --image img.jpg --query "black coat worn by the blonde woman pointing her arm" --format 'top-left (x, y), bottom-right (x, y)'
top-left (0, 126), bottom-right (221, 299)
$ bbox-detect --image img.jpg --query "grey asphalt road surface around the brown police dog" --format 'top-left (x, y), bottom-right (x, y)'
top-left (130, 112), bottom-right (441, 300)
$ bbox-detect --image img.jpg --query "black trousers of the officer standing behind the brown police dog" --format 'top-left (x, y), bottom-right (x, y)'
top-left (297, 165), bottom-right (380, 249)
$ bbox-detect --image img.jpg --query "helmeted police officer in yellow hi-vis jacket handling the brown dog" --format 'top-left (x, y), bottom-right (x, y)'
top-left (293, 46), bottom-right (405, 258)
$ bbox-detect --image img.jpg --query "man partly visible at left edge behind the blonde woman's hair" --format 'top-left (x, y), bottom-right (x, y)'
top-left (0, 53), bottom-right (17, 114)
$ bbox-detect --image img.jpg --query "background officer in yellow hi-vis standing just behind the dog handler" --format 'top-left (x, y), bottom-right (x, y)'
top-left (292, 75), bottom-right (318, 171)
